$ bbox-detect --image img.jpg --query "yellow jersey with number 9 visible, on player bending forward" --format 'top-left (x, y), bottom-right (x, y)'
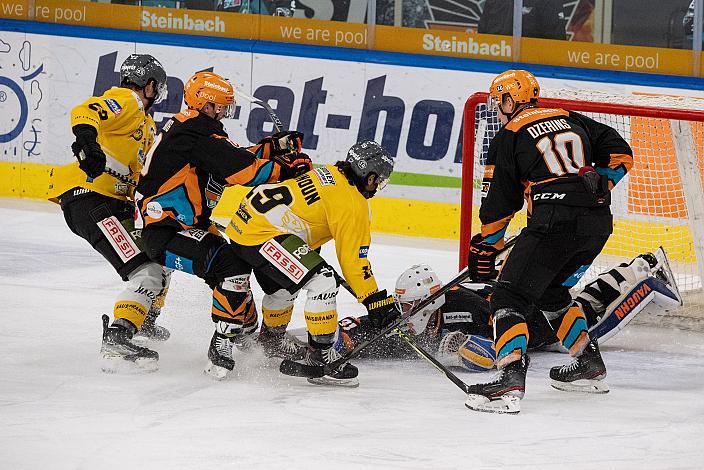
top-left (226, 165), bottom-right (378, 301)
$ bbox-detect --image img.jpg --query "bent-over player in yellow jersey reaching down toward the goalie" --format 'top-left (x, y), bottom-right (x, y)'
top-left (226, 141), bottom-right (398, 387)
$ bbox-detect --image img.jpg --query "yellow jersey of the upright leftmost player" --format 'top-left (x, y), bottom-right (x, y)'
top-left (48, 87), bottom-right (156, 202)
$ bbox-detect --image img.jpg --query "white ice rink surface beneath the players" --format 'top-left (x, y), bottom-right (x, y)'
top-left (0, 199), bottom-right (704, 470)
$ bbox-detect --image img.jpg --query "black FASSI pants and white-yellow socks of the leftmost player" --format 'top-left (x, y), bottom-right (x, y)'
top-left (61, 188), bottom-right (170, 329)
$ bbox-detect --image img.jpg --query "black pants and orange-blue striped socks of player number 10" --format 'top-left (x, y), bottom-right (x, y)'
top-left (491, 204), bottom-right (612, 368)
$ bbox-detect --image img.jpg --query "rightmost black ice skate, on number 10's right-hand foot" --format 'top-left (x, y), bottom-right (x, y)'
top-left (550, 340), bottom-right (609, 393)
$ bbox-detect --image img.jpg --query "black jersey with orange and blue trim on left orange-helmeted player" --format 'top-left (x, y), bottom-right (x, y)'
top-left (135, 110), bottom-right (280, 229)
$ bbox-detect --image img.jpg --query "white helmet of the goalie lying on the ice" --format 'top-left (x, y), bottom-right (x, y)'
top-left (394, 264), bottom-right (445, 334)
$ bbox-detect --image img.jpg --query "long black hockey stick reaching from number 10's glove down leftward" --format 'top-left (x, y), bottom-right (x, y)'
top-left (281, 237), bottom-right (517, 378)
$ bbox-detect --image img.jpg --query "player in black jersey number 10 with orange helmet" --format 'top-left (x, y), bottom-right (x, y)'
top-left (466, 70), bottom-right (633, 412)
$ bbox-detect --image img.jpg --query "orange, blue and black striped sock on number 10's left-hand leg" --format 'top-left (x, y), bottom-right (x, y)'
top-left (494, 308), bottom-right (528, 369)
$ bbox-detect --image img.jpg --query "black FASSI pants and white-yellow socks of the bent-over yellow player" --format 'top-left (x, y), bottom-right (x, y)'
top-left (232, 235), bottom-right (338, 346)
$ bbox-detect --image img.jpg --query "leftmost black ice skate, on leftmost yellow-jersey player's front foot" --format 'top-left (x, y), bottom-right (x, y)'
top-left (100, 315), bottom-right (159, 373)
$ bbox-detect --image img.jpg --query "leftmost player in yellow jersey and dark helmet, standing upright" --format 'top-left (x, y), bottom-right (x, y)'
top-left (48, 54), bottom-right (169, 372)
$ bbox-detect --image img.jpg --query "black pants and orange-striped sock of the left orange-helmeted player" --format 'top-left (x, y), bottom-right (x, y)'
top-left (142, 226), bottom-right (257, 335)
